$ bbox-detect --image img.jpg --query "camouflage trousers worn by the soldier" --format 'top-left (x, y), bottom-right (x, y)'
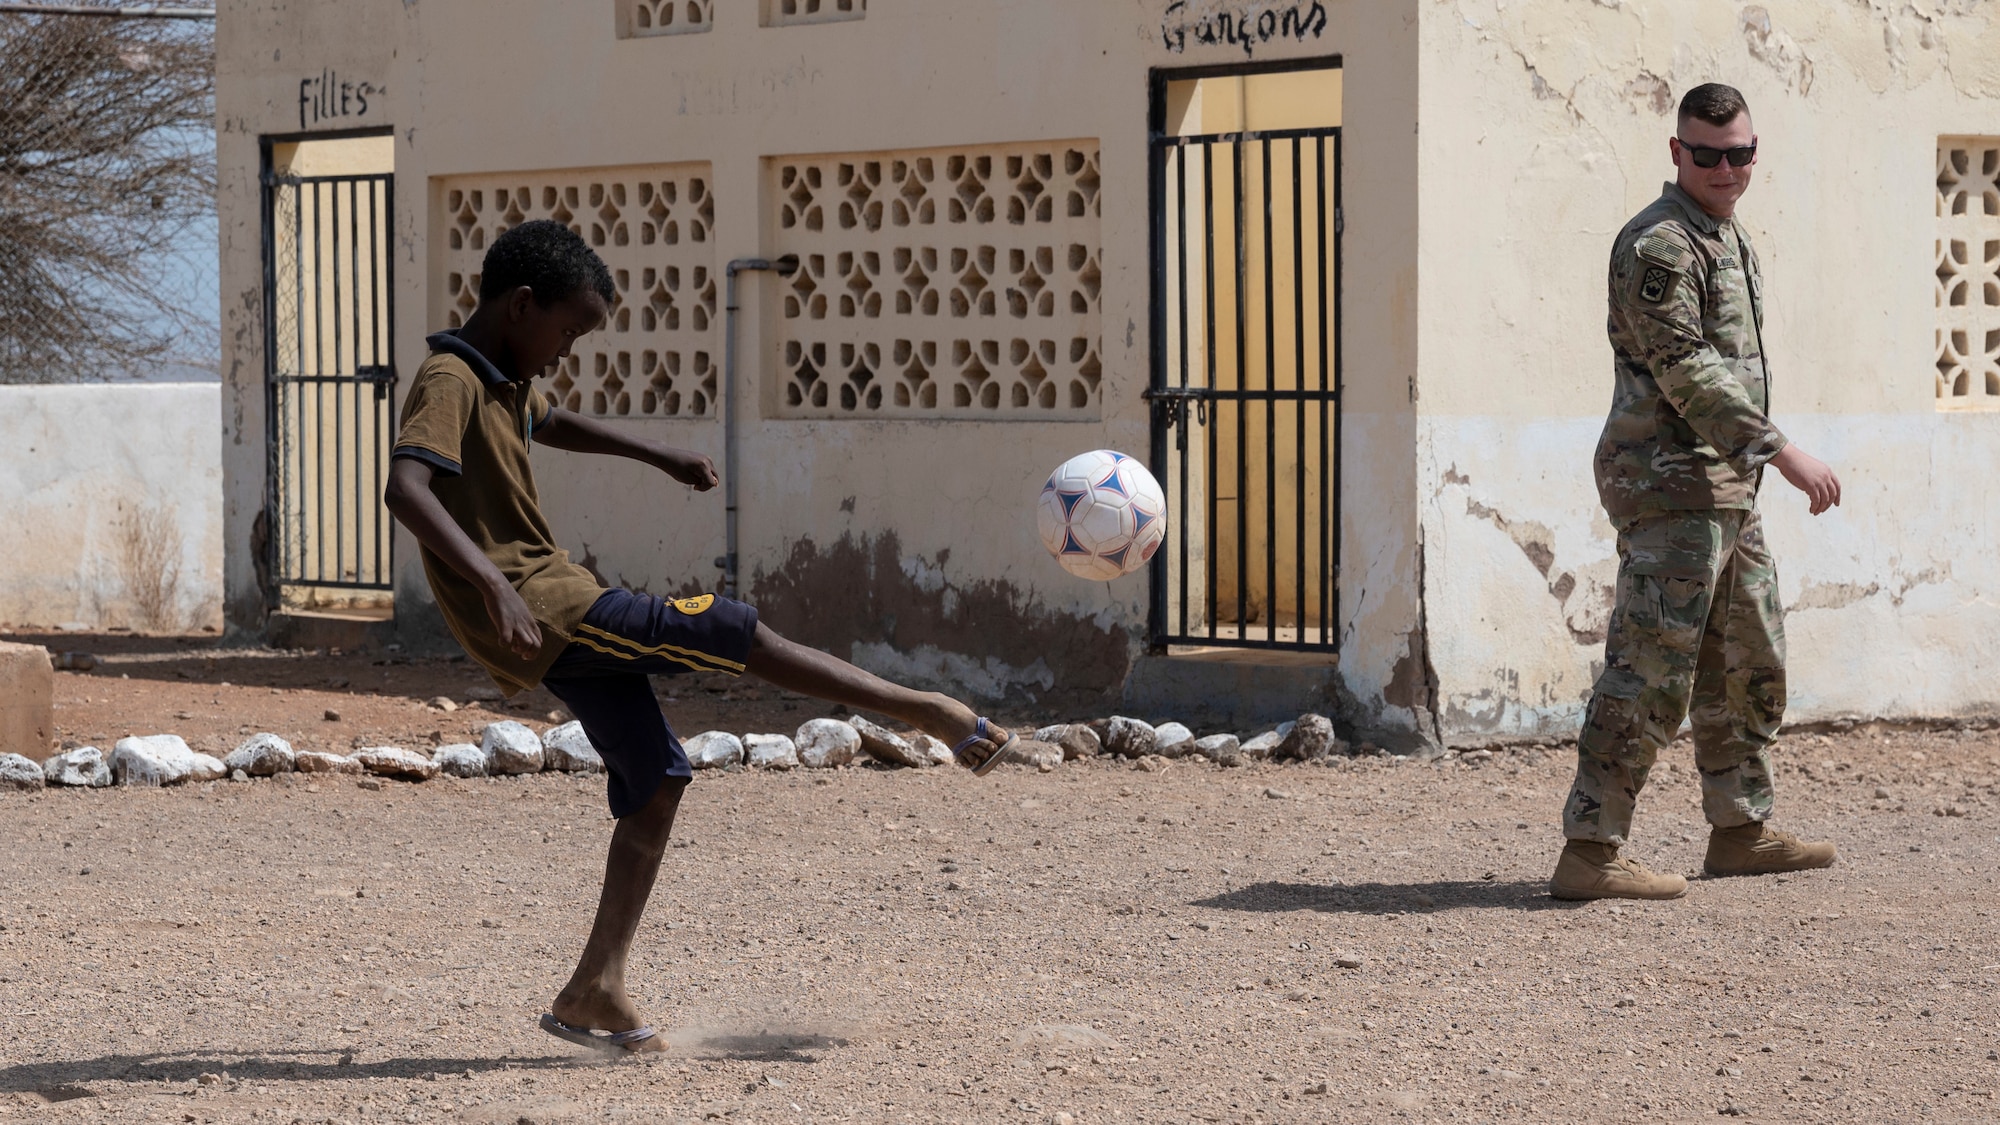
top-left (1562, 508), bottom-right (1784, 845)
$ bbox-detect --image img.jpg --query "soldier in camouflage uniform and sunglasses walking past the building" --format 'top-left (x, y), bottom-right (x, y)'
top-left (1550, 84), bottom-right (1840, 899)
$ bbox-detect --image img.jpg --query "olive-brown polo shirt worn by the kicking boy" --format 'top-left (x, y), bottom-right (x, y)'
top-left (394, 332), bottom-right (604, 695)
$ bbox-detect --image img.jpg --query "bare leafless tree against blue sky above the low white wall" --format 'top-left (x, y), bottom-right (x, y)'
top-left (0, 6), bottom-right (216, 382)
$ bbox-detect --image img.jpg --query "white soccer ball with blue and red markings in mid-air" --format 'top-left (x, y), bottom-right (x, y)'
top-left (1034, 448), bottom-right (1166, 583)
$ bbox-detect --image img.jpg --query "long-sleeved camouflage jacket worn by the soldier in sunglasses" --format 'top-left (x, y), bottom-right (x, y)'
top-left (1596, 184), bottom-right (1786, 520)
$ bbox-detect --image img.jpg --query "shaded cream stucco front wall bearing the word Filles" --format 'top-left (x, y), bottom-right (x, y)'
top-left (218, 0), bottom-right (1436, 728)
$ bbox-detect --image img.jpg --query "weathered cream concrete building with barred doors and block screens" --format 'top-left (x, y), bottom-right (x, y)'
top-left (218, 0), bottom-right (2000, 747)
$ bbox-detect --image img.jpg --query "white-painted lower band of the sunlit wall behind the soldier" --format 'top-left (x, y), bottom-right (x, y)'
top-left (1422, 406), bottom-right (2000, 741)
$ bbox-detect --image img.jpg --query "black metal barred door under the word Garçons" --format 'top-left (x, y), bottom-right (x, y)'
top-left (1146, 72), bottom-right (1342, 653)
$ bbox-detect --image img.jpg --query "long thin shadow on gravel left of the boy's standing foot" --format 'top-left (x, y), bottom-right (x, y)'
top-left (0, 1051), bottom-right (594, 1101)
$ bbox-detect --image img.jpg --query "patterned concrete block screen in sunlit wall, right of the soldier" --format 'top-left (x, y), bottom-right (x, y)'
top-left (1938, 136), bottom-right (2000, 410)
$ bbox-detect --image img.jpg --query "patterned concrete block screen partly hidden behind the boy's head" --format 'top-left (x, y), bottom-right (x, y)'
top-left (436, 164), bottom-right (722, 418)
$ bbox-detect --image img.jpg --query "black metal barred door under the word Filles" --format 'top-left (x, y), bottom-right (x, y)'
top-left (264, 172), bottom-right (396, 591)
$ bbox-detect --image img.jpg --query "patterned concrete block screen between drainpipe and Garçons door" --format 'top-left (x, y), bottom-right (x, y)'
top-left (766, 140), bottom-right (1102, 418)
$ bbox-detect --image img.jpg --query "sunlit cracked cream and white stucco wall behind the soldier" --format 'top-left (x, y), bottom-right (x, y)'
top-left (1416, 0), bottom-right (2000, 741)
